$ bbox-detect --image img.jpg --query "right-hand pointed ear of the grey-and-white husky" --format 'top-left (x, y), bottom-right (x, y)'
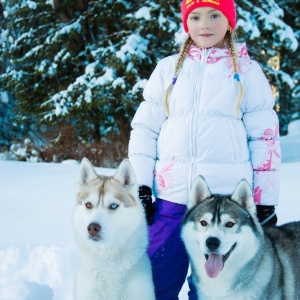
top-left (231, 179), bottom-right (256, 216)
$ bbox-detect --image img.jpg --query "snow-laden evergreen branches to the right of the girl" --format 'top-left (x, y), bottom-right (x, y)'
top-left (236, 0), bottom-right (300, 134)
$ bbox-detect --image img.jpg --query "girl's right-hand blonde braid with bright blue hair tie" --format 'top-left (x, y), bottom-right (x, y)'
top-left (225, 30), bottom-right (244, 117)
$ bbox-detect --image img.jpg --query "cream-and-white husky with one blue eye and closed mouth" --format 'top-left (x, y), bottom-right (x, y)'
top-left (74, 158), bottom-right (155, 300)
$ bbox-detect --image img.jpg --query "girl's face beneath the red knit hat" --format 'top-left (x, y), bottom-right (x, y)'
top-left (187, 6), bottom-right (230, 48)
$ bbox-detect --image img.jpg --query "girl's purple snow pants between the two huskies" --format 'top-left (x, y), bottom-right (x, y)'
top-left (148, 199), bottom-right (197, 300)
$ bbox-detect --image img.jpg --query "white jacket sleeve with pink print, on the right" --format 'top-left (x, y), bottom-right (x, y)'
top-left (242, 62), bottom-right (281, 205)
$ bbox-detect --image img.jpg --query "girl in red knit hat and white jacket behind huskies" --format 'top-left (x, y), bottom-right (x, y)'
top-left (129, 0), bottom-right (280, 300)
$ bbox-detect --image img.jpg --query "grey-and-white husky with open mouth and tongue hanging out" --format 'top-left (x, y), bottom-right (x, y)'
top-left (182, 176), bottom-right (300, 300)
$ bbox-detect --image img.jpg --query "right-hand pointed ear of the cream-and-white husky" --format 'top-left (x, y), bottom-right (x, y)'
top-left (114, 159), bottom-right (138, 192)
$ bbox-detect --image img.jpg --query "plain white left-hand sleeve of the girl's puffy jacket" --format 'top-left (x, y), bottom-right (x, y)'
top-left (128, 59), bottom-right (171, 188)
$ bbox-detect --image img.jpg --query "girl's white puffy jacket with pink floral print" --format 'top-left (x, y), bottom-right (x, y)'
top-left (129, 44), bottom-right (281, 205)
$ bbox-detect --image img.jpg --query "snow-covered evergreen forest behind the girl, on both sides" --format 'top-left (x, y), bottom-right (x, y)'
top-left (0, 0), bottom-right (300, 167)
